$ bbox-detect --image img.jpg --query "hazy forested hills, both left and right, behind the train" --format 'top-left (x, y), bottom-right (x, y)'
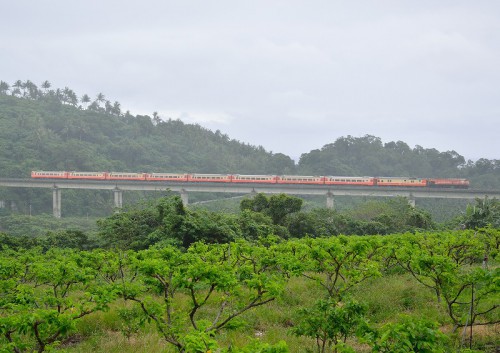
top-left (0, 80), bottom-right (500, 216)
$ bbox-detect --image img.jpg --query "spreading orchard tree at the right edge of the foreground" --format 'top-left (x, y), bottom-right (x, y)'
top-left (391, 231), bottom-right (500, 329)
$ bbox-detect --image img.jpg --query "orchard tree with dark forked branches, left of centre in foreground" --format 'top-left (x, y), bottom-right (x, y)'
top-left (119, 242), bottom-right (284, 353)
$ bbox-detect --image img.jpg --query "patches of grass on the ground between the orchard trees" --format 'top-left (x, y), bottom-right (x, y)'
top-left (62, 268), bottom-right (500, 353)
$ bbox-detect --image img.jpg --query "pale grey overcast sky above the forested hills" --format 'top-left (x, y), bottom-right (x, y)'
top-left (0, 0), bottom-right (500, 159)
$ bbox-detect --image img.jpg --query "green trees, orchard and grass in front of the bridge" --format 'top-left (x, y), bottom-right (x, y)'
top-left (0, 194), bottom-right (500, 353)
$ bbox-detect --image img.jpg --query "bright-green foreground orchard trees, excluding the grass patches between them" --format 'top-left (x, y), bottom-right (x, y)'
top-left (0, 229), bottom-right (500, 352)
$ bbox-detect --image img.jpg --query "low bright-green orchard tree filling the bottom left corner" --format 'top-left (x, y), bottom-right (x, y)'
top-left (0, 249), bottom-right (116, 353)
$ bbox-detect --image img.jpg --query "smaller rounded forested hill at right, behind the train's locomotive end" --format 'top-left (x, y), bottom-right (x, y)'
top-left (298, 135), bottom-right (500, 188)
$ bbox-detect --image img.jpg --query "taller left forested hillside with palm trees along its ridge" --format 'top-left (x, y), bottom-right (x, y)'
top-left (0, 81), bottom-right (294, 177)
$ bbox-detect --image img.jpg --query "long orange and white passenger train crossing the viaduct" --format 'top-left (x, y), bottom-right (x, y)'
top-left (31, 170), bottom-right (470, 189)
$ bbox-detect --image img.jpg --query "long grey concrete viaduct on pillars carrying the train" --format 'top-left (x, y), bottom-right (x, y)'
top-left (0, 179), bottom-right (500, 218)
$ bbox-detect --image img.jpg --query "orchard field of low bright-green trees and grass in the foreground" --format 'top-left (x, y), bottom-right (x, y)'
top-left (0, 229), bottom-right (500, 353)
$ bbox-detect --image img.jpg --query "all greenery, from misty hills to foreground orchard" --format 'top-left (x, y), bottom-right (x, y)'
top-left (0, 81), bottom-right (500, 353)
